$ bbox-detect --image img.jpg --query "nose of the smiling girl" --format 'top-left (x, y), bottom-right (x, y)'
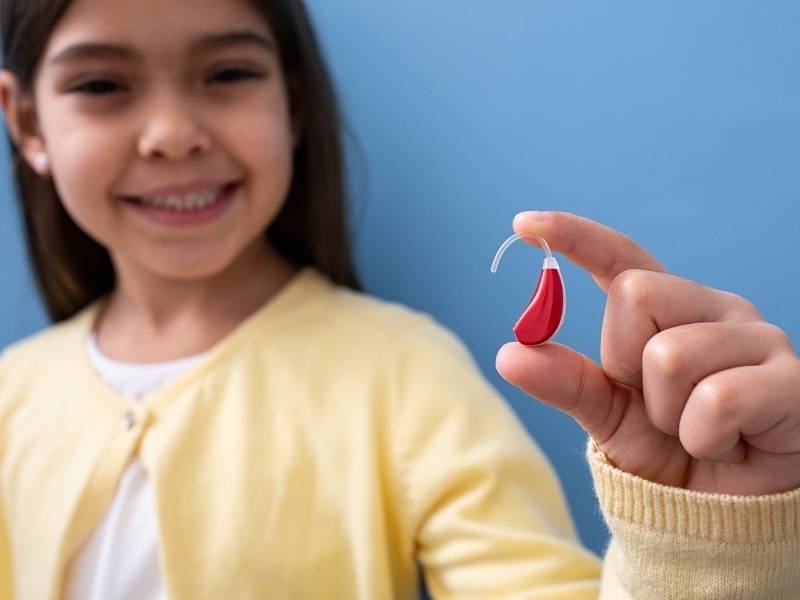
top-left (138, 94), bottom-right (211, 160)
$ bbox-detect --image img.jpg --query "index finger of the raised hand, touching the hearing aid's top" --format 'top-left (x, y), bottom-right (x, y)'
top-left (513, 211), bottom-right (667, 291)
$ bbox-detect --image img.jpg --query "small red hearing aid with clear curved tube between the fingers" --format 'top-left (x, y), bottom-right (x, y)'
top-left (491, 233), bottom-right (567, 346)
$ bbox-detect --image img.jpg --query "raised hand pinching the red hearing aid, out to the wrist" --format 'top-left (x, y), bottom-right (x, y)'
top-left (497, 212), bottom-right (800, 495)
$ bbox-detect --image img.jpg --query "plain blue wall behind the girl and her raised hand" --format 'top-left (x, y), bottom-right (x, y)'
top-left (0, 0), bottom-right (800, 568)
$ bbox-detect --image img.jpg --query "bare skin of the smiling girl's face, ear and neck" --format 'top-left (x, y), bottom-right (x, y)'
top-left (0, 0), bottom-right (301, 362)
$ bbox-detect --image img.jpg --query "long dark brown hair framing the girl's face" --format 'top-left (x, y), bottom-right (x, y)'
top-left (0, 0), bottom-right (361, 322)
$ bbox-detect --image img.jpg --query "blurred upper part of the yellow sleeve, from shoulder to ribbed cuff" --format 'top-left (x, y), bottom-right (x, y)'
top-left (391, 327), bottom-right (601, 600)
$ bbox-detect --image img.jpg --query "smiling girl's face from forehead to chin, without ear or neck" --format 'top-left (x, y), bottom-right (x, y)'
top-left (25, 0), bottom-right (294, 280)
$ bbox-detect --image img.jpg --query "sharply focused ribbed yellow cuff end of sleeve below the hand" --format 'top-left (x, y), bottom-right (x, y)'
top-left (587, 440), bottom-right (800, 600)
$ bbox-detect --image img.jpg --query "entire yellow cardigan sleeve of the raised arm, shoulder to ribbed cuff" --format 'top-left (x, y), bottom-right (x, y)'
top-left (392, 316), bottom-right (800, 600)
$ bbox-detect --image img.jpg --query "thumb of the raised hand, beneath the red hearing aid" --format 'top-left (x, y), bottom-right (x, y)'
top-left (495, 342), bottom-right (629, 443)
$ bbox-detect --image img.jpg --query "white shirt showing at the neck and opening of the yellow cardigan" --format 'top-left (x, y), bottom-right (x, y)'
top-left (64, 333), bottom-right (205, 600)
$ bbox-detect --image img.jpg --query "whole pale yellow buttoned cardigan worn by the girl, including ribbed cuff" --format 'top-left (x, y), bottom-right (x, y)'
top-left (0, 268), bottom-right (800, 600)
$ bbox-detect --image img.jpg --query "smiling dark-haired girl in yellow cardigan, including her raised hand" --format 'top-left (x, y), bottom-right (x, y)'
top-left (0, 0), bottom-right (800, 600)
